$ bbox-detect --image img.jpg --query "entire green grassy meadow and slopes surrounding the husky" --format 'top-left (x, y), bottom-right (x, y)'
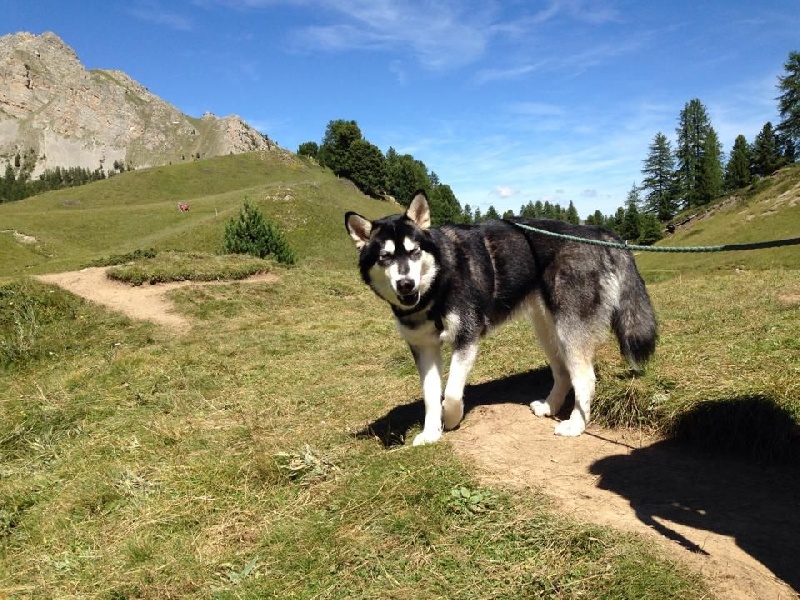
top-left (0, 153), bottom-right (800, 600)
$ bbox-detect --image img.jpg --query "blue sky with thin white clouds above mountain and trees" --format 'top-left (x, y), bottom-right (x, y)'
top-left (0, 0), bottom-right (800, 217)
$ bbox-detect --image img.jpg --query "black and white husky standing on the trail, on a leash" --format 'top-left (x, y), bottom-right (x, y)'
top-left (345, 193), bottom-right (656, 446)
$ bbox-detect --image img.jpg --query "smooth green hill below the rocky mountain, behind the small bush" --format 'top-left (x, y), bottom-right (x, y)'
top-left (0, 152), bottom-right (390, 277)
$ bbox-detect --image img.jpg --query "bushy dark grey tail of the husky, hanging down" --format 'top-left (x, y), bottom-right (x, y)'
top-left (611, 266), bottom-right (658, 373)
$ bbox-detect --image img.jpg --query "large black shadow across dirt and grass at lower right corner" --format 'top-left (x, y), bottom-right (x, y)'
top-left (590, 397), bottom-right (800, 591)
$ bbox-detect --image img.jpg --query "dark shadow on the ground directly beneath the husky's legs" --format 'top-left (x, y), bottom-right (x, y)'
top-left (355, 367), bottom-right (560, 448)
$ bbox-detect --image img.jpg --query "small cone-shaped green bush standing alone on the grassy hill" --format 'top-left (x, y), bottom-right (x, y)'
top-left (222, 198), bottom-right (297, 265)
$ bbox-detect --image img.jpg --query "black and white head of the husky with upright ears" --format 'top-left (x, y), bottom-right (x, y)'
top-left (344, 192), bottom-right (436, 310)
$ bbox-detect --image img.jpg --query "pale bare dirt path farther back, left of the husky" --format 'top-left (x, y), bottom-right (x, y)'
top-left (38, 267), bottom-right (277, 333)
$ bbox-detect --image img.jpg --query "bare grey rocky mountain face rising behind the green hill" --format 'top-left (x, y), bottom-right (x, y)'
top-left (0, 33), bottom-right (277, 176)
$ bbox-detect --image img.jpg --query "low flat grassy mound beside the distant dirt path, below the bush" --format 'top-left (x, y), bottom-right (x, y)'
top-left (107, 252), bottom-right (274, 285)
